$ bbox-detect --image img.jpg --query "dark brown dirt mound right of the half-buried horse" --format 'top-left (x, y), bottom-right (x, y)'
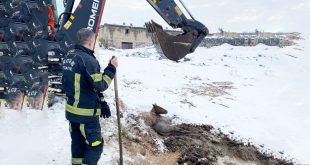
top-left (164, 124), bottom-right (293, 165)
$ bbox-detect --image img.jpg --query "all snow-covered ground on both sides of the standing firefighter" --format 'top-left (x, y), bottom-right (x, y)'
top-left (0, 35), bottom-right (310, 165)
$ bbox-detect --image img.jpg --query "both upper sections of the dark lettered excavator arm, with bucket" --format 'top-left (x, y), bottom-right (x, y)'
top-left (57, 0), bottom-right (209, 61)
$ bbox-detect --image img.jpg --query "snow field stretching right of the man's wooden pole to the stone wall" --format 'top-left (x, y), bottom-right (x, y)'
top-left (98, 36), bottom-right (310, 163)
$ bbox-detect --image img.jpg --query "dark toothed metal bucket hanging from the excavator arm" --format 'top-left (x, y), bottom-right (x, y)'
top-left (145, 21), bottom-right (197, 61)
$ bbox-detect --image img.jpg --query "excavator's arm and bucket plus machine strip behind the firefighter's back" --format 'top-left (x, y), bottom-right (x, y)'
top-left (47, 0), bottom-right (208, 93)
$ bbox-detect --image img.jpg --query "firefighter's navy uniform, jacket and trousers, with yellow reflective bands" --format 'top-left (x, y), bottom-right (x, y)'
top-left (62, 45), bottom-right (116, 165)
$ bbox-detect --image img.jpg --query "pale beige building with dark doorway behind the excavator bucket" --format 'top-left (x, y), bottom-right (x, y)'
top-left (98, 24), bottom-right (181, 49)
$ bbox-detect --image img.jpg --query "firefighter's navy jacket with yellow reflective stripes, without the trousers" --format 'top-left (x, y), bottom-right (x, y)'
top-left (62, 45), bottom-right (116, 123)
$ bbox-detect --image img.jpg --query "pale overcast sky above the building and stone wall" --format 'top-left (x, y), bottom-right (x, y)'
top-left (56, 0), bottom-right (310, 34)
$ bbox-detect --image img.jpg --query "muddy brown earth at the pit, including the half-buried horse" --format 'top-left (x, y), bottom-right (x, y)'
top-left (125, 104), bottom-right (293, 165)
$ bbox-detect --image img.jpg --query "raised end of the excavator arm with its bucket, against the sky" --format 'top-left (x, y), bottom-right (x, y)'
top-left (146, 0), bottom-right (209, 61)
